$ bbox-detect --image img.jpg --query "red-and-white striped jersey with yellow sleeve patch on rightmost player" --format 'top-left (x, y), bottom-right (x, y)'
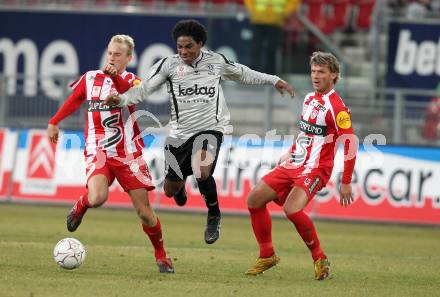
top-left (286, 89), bottom-right (357, 183)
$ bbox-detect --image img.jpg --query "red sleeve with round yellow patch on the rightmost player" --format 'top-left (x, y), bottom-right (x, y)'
top-left (333, 99), bottom-right (358, 184)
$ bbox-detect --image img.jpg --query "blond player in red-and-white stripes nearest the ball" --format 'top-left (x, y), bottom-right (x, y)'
top-left (47, 35), bottom-right (174, 273)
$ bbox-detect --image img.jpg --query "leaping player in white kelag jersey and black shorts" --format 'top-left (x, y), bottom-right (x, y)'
top-left (106, 20), bottom-right (293, 244)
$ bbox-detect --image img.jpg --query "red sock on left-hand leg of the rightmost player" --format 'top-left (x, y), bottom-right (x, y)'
top-left (248, 206), bottom-right (275, 258)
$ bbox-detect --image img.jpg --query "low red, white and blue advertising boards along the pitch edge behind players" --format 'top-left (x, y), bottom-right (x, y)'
top-left (0, 129), bottom-right (440, 225)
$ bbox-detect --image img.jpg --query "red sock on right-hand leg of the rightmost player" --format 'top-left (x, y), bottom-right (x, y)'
top-left (287, 210), bottom-right (327, 261)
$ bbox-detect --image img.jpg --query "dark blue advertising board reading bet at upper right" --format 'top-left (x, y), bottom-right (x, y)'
top-left (386, 22), bottom-right (440, 90)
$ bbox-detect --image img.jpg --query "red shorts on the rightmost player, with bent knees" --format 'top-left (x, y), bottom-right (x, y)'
top-left (262, 166), bottom-right (330, 206)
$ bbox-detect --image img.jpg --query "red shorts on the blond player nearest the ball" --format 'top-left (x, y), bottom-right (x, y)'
top-left (86, 154), bottom-right (155, 192)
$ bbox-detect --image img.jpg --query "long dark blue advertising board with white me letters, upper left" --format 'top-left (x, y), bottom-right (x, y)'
top-left (0, 11), bottom-right (249, 103)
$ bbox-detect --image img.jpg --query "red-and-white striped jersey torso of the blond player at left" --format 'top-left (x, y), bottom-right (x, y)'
top-left (71, 70), bottom-right (144, 158)
